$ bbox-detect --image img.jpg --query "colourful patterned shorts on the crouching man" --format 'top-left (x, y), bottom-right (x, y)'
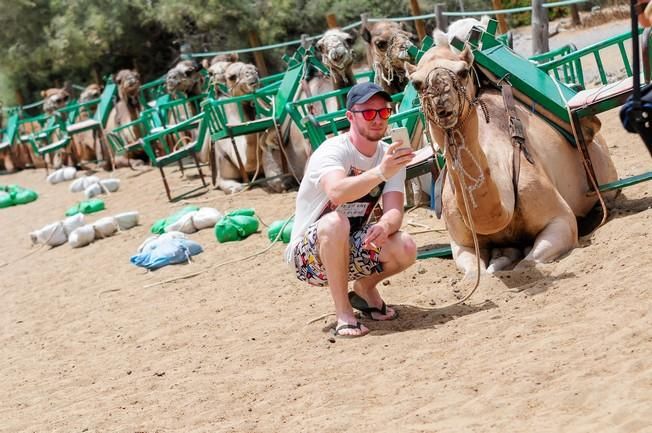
top-left (293, 221), bottom-right (383, 286)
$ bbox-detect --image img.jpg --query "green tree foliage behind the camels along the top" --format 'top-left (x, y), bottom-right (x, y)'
top-left (0, 0), bottom-right (580, 106)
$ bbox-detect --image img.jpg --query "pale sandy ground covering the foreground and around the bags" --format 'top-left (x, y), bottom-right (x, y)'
top-left (0, 20), bottom-right (652, 433)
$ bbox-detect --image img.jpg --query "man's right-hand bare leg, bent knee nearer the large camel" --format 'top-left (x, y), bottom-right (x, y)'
top-left (354, 232), bottom-right (417, 320)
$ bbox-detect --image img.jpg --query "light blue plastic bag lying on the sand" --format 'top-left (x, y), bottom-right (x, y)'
top-left (129, 238), bottom-right (204, 270)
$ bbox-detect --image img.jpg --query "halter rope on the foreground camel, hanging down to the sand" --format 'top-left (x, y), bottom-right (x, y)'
top-left (419, 67), bottom-right (489, 308)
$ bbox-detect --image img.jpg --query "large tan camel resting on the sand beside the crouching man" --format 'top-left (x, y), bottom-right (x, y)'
top-left (407, 38), bottom-right (617, 277)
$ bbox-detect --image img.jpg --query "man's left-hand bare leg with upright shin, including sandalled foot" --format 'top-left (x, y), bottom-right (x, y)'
top-left (317, 212), bottom-right (369, 335)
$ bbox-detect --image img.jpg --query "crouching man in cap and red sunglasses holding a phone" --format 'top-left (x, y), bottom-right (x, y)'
top-left (286, 83), bottom-right (416, 337)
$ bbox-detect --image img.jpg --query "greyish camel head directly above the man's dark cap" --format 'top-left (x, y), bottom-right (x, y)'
top-left (315, 29), bottom-right (355, 87)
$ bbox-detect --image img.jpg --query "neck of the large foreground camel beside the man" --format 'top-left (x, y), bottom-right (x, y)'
top-left (431, 107), bottom-right (514, 234)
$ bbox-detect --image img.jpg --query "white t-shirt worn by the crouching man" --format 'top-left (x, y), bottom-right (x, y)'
top-left (285, 133), bottom-right (405, 263)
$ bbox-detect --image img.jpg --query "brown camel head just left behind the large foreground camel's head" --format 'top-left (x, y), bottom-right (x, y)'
top-left (361, 21), bottom-right (416, 94)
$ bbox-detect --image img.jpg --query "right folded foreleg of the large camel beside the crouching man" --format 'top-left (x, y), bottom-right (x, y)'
top-left (518, 215), bottom-right (577, 267)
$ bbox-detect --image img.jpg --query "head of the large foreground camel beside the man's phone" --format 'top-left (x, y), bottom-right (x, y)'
top-left (406, 37), bottom-right (476, 129)
